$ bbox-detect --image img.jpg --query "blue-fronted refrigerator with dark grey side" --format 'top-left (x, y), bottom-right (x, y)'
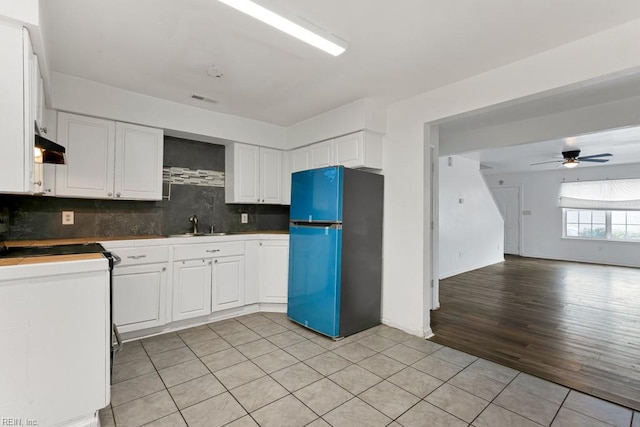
top-left (287, 166), bottom-right (384, 338)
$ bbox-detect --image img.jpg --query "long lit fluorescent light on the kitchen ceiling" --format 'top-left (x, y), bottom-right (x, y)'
top-left (219, 0), bottom-right (347, 56)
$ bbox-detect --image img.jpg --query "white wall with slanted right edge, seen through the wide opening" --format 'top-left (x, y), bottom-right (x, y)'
top-left (439, 156), bottom-right (504, 279)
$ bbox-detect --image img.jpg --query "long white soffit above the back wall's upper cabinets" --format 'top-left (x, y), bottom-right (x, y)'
top-left (51, 73), bottom-right (287, 149)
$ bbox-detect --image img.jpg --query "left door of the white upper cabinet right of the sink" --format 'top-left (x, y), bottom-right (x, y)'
top-left (233, 144), bottom-right (260, 203)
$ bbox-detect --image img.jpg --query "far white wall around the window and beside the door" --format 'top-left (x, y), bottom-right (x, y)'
top-left (486, 164), bottom-right (640, 267)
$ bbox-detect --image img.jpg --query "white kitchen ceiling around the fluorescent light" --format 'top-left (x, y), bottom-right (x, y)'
top-left (42, 0), bottom-right (640, 127)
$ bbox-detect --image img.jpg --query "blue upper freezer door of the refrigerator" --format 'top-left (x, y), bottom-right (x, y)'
top-left (289, 166), bottom-right (344, 223)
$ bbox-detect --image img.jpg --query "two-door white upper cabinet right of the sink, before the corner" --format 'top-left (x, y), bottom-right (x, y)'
top-left (225, 143), bottom-right (282, 204)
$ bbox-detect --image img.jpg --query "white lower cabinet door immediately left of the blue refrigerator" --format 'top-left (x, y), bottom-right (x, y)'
top-left (260, 240), bottom-right (289, 303)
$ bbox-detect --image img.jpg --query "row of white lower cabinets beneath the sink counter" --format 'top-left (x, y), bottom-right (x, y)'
top-left (107, 236), bottom-right (289, 335)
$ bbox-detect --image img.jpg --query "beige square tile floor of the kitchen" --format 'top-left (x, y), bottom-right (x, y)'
top-left (100, 313), bottom-right (640, 427)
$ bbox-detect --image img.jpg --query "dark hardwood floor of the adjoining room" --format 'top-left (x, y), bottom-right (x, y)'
top-left (431, 256), bottom-right (640, 410)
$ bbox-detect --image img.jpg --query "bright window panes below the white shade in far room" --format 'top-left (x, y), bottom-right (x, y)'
top-left (563, 209), bottom-right (640, 240)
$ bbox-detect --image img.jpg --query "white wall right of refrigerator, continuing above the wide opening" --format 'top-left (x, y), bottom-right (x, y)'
top-left (382, 20), bottom-right (640, 335)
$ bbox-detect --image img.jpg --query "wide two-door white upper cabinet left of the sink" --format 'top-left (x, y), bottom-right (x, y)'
top-left (56, 113), bottom-right (163, 200)
